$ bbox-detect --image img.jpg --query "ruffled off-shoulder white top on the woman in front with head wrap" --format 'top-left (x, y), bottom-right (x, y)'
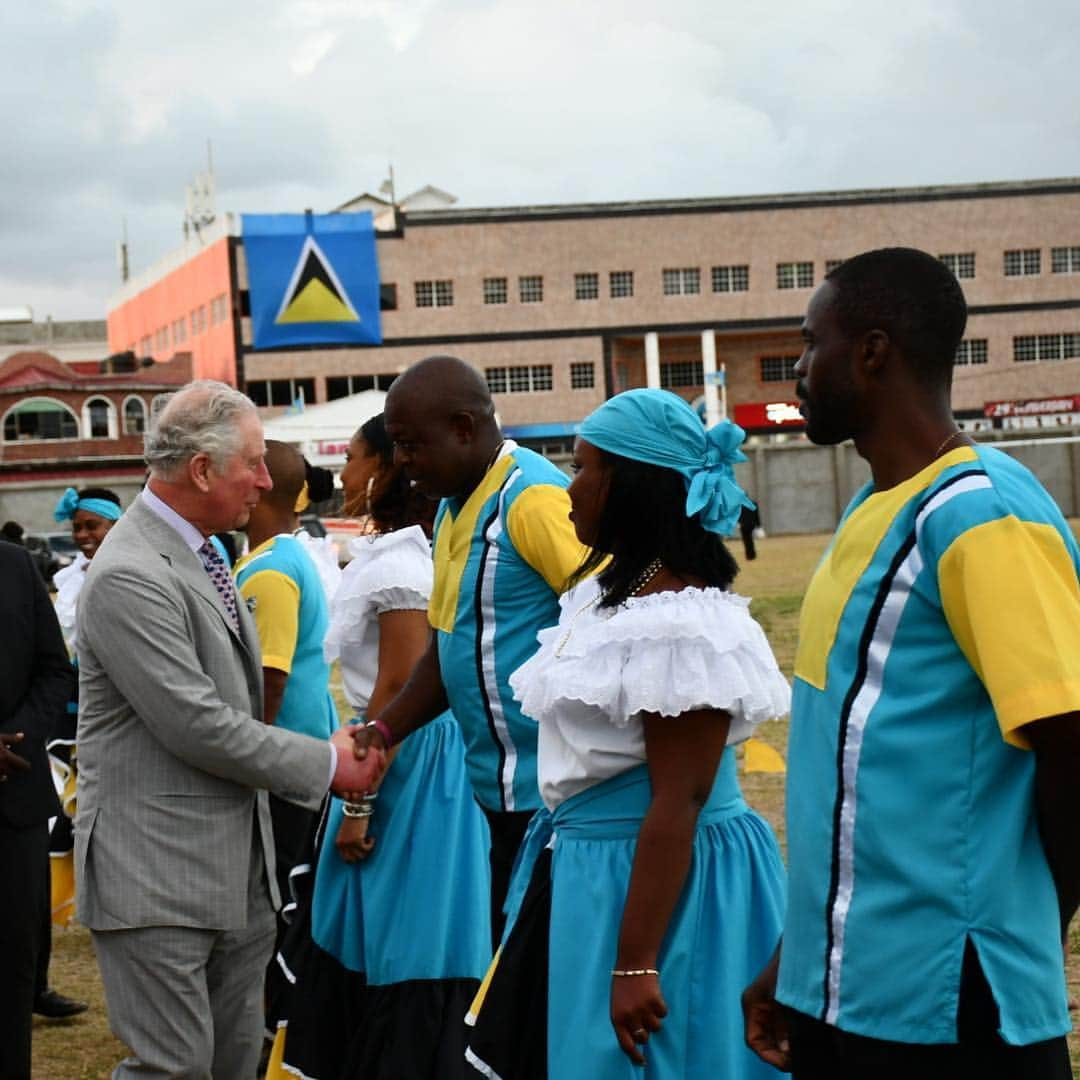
top-left (510, 579), bottom-right (791, 810)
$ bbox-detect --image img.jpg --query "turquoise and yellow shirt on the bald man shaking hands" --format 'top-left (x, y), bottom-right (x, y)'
top-left (428, 443), bottom-right (585, 811)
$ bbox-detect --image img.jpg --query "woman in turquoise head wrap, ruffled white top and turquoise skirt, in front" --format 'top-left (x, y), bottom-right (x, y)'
top-left (467, 390), bottom-right (789, 1080)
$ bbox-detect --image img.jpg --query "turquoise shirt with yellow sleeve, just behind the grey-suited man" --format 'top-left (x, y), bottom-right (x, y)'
top-left (233, 534), bottom-right (338, 739)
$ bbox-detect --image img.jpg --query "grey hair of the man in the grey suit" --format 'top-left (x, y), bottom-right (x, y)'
top-left (143, 379), bottom-right (255, 480)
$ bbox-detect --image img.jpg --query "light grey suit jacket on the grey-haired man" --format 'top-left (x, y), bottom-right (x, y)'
top-left (75, 499), bottom-right (330, 930)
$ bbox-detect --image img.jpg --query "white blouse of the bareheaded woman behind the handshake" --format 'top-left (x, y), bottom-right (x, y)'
top-left (323, 525), bottom-right (432, 713)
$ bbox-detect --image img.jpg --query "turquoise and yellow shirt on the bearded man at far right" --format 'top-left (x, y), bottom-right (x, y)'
top-left (778, 447), bottom-right (1080, 1044)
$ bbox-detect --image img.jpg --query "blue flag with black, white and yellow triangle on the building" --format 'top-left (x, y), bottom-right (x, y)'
top-left (242, 213), bottom-right (382, 349)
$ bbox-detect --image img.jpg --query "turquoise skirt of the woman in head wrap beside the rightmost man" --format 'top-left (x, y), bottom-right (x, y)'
top-left (481, 750), bottom-right (784, 1080)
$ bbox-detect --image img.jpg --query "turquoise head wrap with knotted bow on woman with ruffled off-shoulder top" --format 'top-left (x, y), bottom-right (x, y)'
top-left (578, 390), bottom-right (754, 536)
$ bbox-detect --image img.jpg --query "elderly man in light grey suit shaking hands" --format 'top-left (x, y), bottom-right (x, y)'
top-left (76, 382), bottom-right (380, 1080)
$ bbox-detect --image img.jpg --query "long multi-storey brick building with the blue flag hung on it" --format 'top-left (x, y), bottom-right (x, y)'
top-left (108, 179), bottom-right (1080, 448)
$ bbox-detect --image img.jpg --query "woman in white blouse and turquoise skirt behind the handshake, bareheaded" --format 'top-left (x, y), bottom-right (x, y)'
top-left (268, 416), bottom-right (491, 1080)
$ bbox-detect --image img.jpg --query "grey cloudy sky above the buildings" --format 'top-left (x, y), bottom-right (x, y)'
top-left (0, 0), bottom-right (1080, 319)
